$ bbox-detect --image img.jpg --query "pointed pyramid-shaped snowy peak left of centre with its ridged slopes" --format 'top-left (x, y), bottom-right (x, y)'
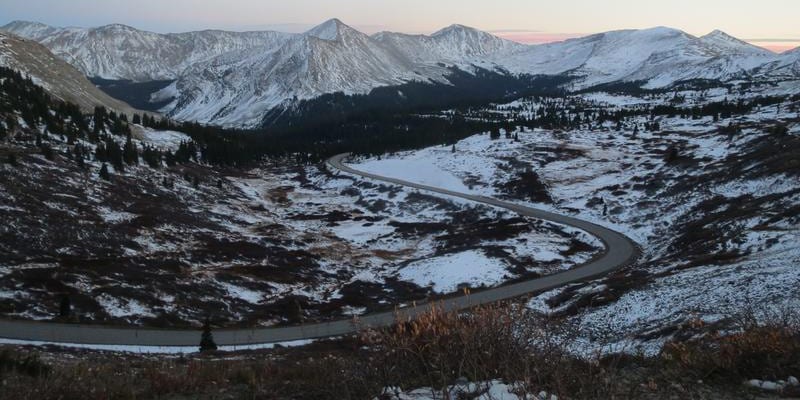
top-left (166, 20), bottom-right (432, 126)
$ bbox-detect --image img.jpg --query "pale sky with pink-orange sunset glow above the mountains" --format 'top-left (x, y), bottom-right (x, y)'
top-left (0, 0), bottom-right (800, 51)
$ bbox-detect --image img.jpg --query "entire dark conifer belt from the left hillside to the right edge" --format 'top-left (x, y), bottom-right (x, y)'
top-left (0, 64), bottom-right (800, 170)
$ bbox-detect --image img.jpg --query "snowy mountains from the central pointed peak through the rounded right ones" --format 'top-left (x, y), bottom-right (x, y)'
top-left (164, 20), bottom-right (792, 126)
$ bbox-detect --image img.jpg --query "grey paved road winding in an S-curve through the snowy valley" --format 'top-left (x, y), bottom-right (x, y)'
top-left (0, 154), bottom-right (639, 347)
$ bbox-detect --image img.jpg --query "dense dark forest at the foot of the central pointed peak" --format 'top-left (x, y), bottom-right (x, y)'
top-left (126, 69), bottom-right (568, 165)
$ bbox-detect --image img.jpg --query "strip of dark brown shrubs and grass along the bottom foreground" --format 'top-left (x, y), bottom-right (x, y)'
top-left (0, 305), bottom-right (800, 400)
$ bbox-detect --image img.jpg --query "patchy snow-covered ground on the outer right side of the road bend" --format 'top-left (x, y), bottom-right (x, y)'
top-left (353, 88), bottom-right (800, 351)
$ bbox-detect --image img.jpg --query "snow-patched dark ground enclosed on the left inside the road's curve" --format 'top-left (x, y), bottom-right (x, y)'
top-left (0, 122), bottom-right (600, 325)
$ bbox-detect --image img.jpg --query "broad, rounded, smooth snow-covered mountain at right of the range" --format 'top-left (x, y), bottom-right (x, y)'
top-left (506, 27), bottom-right (777, 88)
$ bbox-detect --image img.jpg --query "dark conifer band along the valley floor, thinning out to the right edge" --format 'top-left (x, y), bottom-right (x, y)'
top-left (122, 88), bottom-right (795, 166)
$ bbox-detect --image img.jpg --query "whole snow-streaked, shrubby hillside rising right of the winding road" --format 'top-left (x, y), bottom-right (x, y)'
top-left (355, 85), bottom-right (800, 353)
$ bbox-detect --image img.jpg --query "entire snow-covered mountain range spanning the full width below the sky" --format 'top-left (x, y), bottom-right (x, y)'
top-left (0, 19), bottom-right (800, 127)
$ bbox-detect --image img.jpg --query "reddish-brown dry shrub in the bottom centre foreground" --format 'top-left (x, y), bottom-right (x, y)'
top-left (362, 304), bottom-right (620, 398)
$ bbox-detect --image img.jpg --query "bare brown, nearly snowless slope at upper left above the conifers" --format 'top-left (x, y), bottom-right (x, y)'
top-left (0, 32), bottom-right (135, 114)
